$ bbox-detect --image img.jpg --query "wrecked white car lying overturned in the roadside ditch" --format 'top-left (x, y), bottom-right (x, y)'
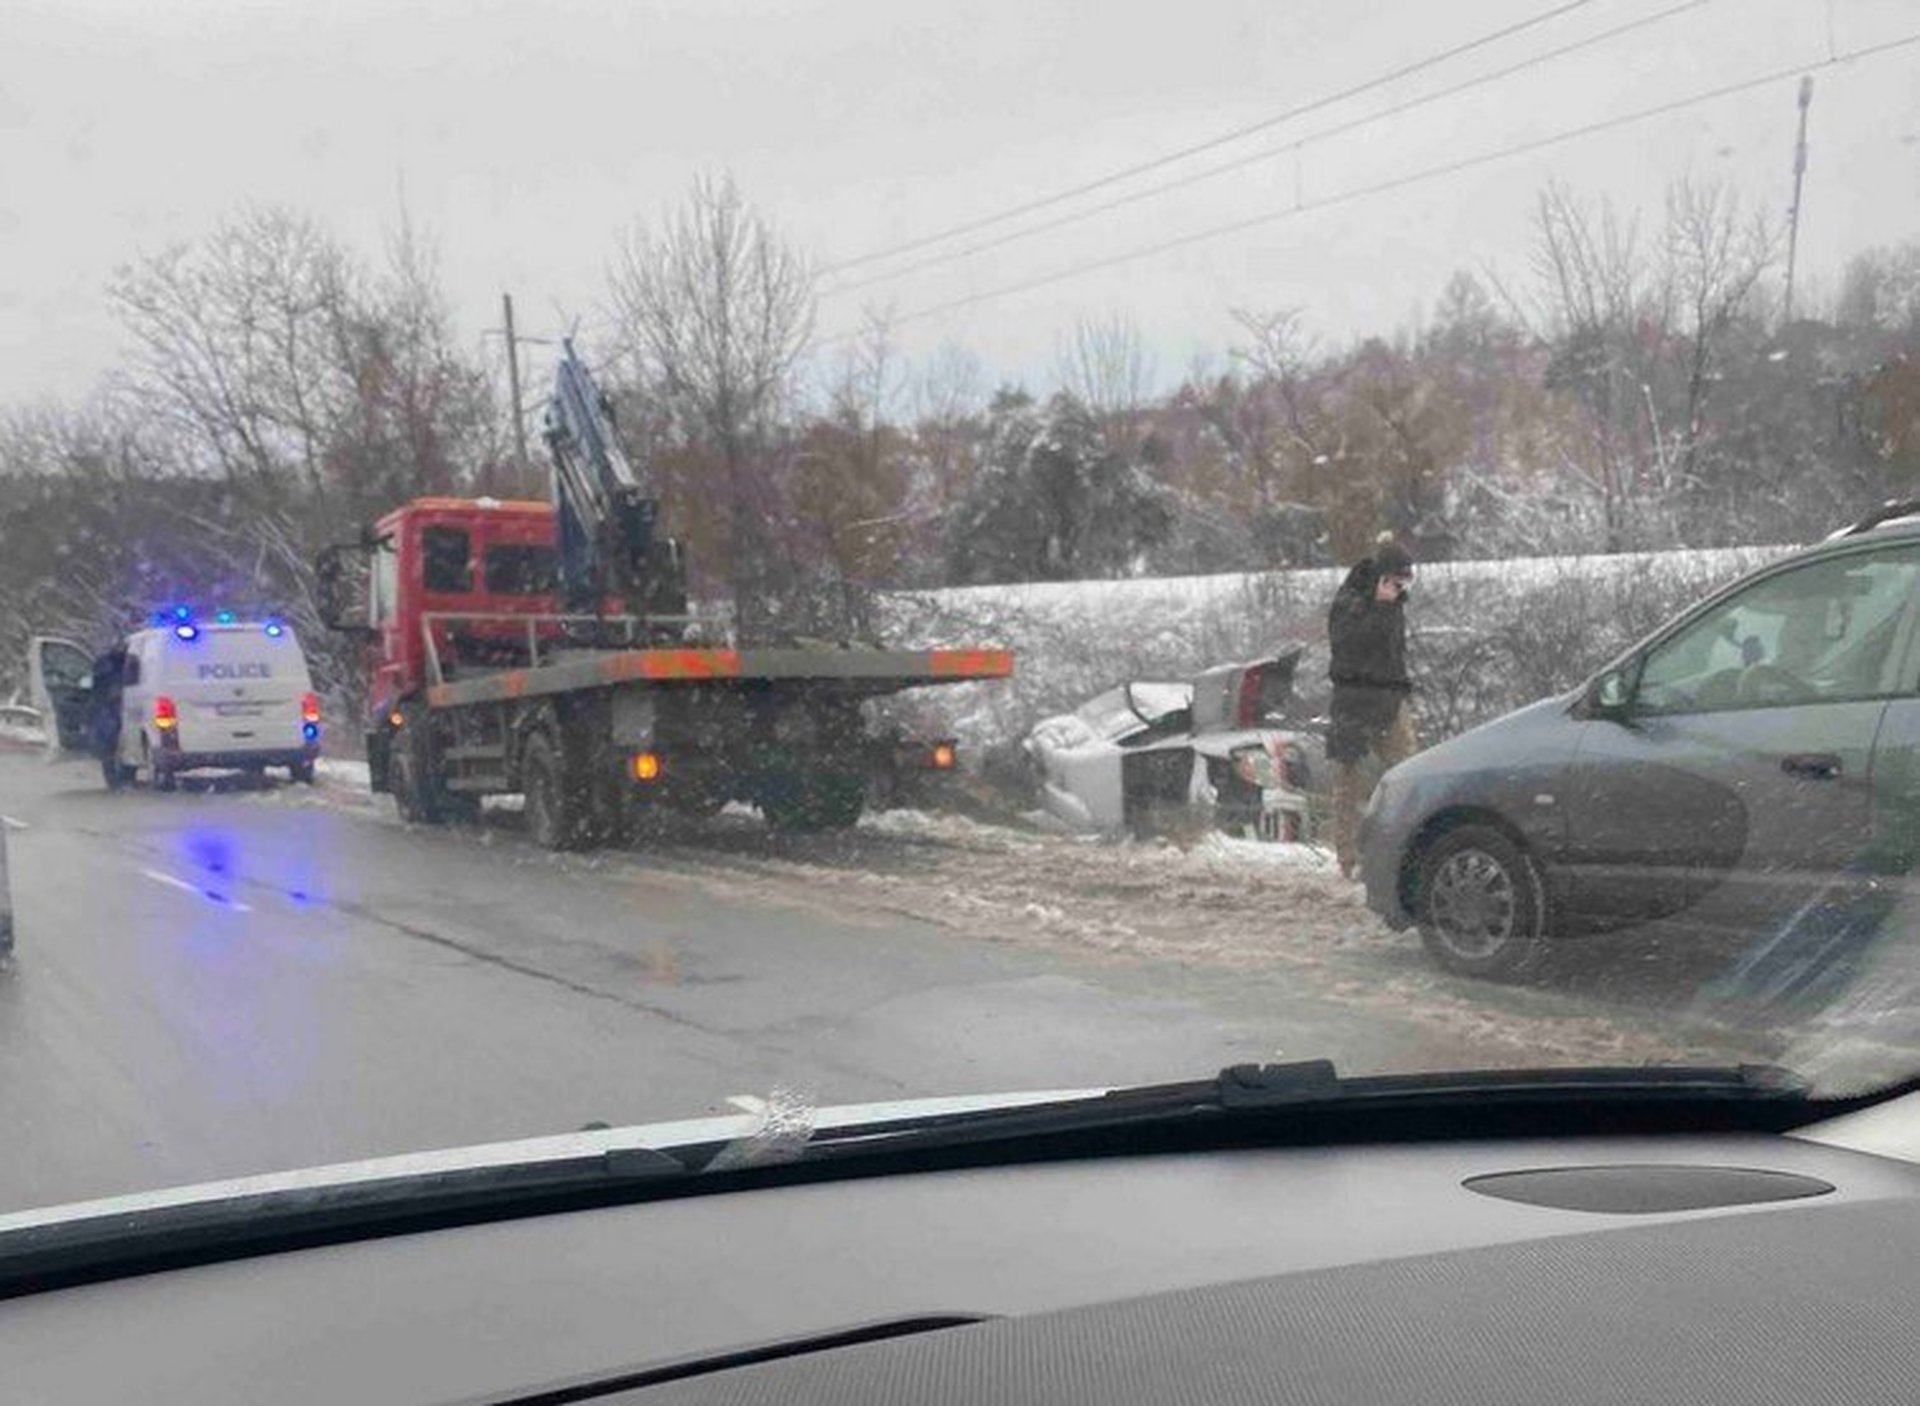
top-left (1023, 649), bottom-right (1313, 841)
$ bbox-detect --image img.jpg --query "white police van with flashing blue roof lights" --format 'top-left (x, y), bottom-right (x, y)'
top-left (96, 615), bottom-right (321, 791)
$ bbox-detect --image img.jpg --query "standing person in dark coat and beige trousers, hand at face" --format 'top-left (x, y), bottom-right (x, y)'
top-left (1327, 532), bottom-right (1419, 878)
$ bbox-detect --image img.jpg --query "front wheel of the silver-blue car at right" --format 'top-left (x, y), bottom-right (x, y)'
top-left (1413, 824), bottom-right (1548, 980)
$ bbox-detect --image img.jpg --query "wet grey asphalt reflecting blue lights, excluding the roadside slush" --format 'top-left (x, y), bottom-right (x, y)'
top-left (0, 751), bottom-right (1320, 1210)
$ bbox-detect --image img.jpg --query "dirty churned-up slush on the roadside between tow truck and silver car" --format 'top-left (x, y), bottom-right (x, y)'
top-left (652, 811), bottom-right (1761, 1066)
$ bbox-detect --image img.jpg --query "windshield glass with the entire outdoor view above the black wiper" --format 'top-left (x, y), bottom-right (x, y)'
top-left (0, 0), bottom-right (1920, 1212)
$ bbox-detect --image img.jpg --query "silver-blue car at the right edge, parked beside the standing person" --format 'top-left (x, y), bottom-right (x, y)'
top-left (1361, 503), bottom-right (1920, 976)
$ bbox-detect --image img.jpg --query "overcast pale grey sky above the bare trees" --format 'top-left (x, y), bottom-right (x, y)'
top-left (0, 0), bottom-right (1920, 403)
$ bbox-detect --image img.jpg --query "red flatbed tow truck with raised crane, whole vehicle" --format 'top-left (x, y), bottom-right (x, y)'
top-left (315, 346), bottom-right (1014, 849)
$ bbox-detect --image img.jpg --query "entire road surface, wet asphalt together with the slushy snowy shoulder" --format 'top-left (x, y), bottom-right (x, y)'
top-left (0, 749), bottom-right (1753, 1208)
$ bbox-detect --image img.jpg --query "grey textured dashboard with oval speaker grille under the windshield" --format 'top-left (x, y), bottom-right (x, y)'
top-left (0, 1101), bottom-right (1920, 1406)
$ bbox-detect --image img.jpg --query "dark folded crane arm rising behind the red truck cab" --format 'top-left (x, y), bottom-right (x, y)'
top-left (545, 338), bottom-right (687, 617)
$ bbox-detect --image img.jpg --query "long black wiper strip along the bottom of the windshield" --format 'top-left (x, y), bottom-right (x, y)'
top-left (0, 1060), bottom-right (1807, 1298)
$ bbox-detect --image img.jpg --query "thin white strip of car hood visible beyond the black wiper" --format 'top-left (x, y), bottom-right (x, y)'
top-left (0, 1089), bottom-right (1108, 1235)
